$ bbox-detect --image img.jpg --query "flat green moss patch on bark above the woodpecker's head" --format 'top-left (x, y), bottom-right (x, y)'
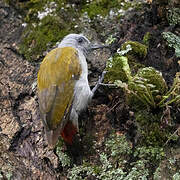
top-left (17, 0), bottom-right (146, 61)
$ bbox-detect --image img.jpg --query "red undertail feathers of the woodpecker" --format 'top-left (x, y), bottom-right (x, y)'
top-left (61, 121), bottom-right (77, 145)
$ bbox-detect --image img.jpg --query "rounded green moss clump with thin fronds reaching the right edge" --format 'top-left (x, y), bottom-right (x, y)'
top-left (126, 67), bottom-right (180, 111)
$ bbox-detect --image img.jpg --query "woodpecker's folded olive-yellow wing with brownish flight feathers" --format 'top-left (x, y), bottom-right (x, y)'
top-left (38, 47), bottom-right (81, 146)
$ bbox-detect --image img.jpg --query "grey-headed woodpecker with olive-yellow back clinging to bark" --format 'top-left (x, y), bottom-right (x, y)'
top-left (37, 34), bottom-right (104, 147)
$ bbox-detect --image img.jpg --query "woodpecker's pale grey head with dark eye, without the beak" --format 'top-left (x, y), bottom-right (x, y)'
top-left (58, 34), bottom-right (90, 54)
